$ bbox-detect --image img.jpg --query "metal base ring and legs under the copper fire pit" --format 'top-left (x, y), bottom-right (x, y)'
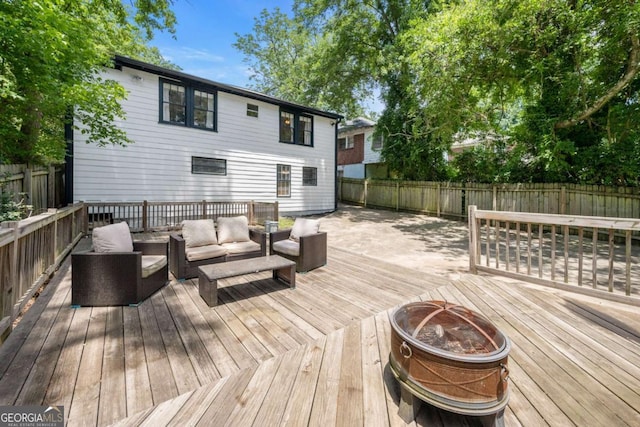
top-left (389, 363), bottom-right (509, 427)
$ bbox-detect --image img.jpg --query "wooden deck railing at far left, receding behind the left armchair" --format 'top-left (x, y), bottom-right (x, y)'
top-left (0, 204), bottom-right (84, 341)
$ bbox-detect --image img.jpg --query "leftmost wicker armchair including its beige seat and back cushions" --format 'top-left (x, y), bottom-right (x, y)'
top-left (71, 222), bottom-right (169, 306)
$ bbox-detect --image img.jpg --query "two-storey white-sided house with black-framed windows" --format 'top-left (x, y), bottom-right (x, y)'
top-left (67, 56), bottom-right (342, 214)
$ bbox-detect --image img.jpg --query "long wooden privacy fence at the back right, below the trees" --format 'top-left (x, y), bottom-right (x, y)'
top-left (338, 178), bottom-right (640, 219)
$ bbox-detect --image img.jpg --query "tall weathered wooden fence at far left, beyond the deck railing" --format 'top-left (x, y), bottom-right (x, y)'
top-left (0, 165), bottom-right (65, 214)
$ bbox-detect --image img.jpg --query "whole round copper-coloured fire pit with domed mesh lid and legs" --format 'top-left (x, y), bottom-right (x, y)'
top-left (389, 301), bottom-right (511, 424)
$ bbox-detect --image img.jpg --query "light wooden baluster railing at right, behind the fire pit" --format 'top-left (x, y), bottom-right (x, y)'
top-left (469, 206), bottom-right (640, 305)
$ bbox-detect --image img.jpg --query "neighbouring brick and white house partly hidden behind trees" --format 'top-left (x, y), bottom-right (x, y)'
top-left (338, 117), bottom-right (388, 179)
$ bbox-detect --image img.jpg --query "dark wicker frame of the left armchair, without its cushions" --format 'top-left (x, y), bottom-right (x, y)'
top-left (71, 242), bottom-right (169, 306)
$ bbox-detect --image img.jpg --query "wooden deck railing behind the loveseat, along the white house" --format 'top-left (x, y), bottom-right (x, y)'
top-left (84, 200), bottom-right (279, 232)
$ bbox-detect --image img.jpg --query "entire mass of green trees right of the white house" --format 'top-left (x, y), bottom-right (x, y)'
top-left (234, 0), bottom-right (640, 185)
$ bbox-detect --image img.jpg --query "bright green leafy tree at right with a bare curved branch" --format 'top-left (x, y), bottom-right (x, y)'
top-left (404, 0), bottom-right (640, 182)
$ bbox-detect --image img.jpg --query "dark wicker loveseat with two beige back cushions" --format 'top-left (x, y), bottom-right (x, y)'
top-left (169, 216), bottom-right (267, 280)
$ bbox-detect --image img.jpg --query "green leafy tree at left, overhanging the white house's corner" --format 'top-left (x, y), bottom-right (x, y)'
top-left (0, 0), bottom-right (175, 163)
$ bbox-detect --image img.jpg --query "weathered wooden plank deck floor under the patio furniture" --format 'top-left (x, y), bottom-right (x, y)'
top-left (0, 241), bottom-right (640, 426)
